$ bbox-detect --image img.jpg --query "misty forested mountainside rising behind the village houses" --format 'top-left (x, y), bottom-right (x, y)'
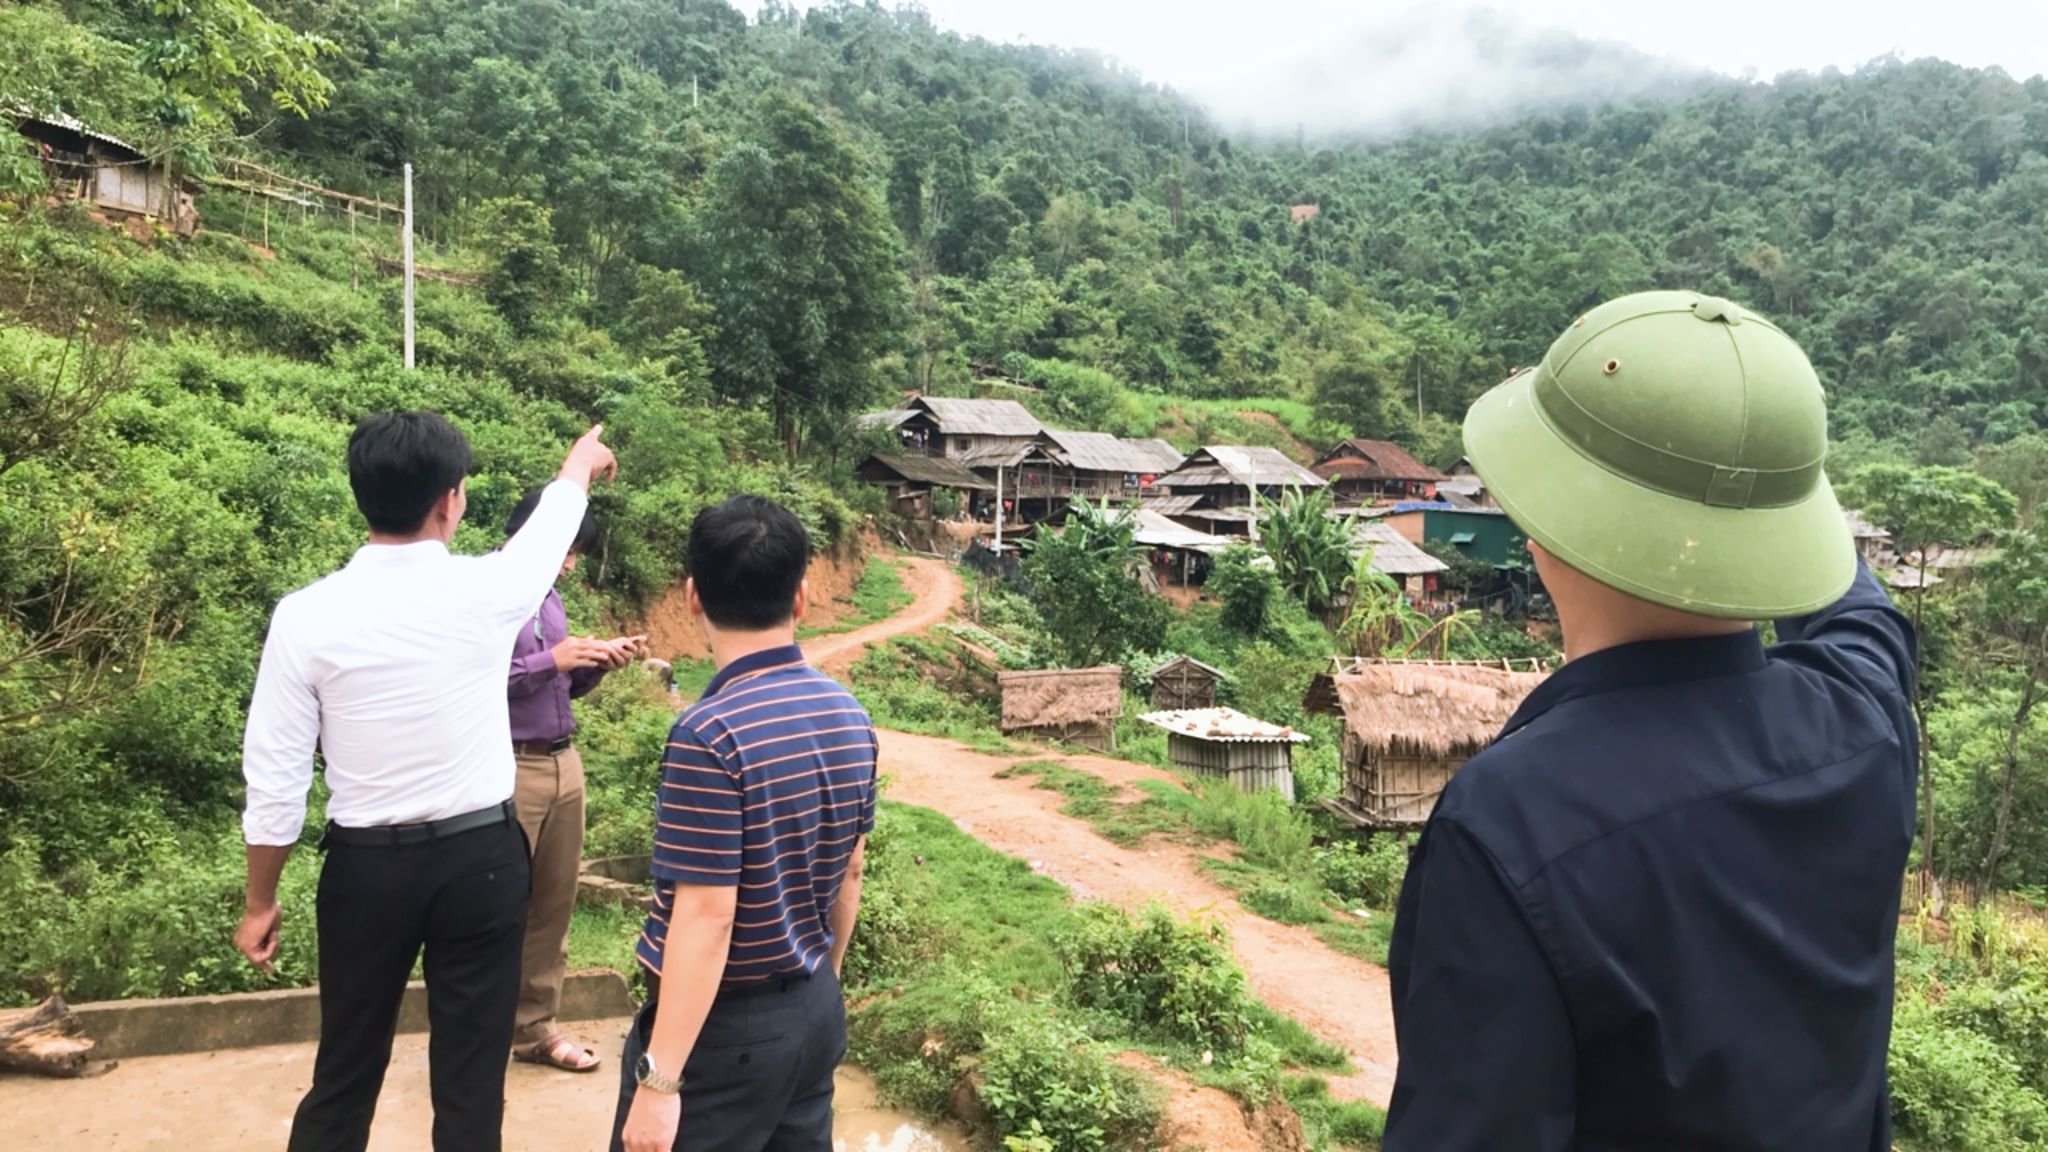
top-left (16, 0), bottom-right (2048, 457)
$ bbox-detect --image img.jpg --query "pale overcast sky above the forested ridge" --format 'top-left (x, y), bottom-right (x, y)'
top-left (856, 0), bottom-right (2048, 131)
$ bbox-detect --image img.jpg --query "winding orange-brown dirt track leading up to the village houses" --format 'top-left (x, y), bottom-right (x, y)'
top-left (827, 558), bottom-right (1395, 1107)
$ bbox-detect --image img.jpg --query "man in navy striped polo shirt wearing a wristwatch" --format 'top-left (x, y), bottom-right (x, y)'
top-left (612, 496), bottom-right (877, 1152)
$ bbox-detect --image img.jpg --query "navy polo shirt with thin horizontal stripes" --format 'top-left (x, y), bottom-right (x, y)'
top-left (637, 644), bottom-right (877, 988)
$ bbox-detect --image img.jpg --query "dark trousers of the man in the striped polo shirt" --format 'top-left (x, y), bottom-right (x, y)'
top-left (612, 968), bottom-right (846, 1152)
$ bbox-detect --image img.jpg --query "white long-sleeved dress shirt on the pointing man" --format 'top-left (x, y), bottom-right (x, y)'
top-left (242, 480), bottom-right (588, 845)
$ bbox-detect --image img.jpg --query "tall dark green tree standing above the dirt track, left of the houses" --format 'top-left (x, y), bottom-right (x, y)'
top-left (692, 90), bottom-right (903, 453)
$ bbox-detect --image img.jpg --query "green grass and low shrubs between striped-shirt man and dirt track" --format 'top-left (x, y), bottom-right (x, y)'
top-left (848, 804), bottom-right (1370, 1150)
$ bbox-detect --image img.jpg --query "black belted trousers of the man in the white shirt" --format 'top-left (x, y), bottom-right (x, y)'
top-left (289, 818), bottom-right (528, 1152)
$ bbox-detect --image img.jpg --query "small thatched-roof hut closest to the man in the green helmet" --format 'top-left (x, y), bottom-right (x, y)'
top-left (1303, 660), bottom-right (1548, 828)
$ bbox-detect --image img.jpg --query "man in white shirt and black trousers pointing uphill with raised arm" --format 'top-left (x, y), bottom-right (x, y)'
top-left (236, 412), bottom-right (616, 1152)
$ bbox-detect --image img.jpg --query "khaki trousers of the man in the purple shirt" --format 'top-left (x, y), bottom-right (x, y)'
top-left (512, 744), bottom-right (584, 1045)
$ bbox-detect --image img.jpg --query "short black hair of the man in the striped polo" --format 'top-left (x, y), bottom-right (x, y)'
top-left (688, 492), bottom-right (811, 631)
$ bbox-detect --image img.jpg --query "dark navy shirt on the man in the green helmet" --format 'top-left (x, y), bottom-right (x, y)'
top-left (1384, 572), bottom-right (1917, 1152)
